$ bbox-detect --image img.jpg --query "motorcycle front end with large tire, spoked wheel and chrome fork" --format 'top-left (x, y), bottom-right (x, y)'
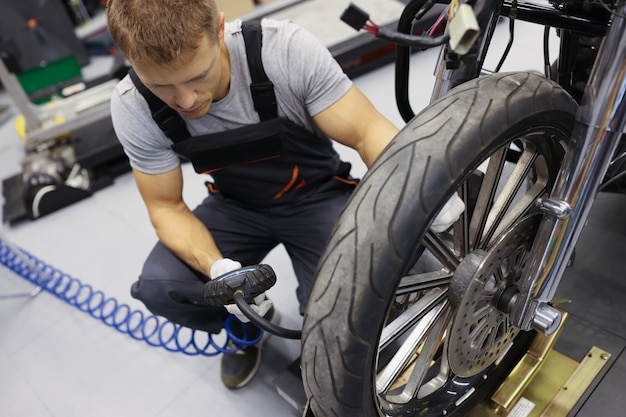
top-left (301, 0), bottom-right (626, 417)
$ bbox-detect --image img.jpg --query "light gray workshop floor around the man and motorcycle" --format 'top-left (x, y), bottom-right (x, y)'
top-left (0, 5), bottom-right (626, 417)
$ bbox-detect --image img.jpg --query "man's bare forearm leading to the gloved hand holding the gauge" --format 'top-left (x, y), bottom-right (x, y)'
top-left (133, 166), bottom-right (222, 276)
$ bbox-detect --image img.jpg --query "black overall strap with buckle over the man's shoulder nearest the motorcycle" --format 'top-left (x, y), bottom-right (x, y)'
top-left (241, 21), bottom-right (278, 121)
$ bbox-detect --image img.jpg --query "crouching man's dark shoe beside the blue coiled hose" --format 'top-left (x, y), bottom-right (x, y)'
top-left (221, 306), bottom-right (280, 389)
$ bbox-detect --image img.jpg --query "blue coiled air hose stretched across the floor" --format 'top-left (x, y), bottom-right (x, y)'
top-left (0, 236), bottom-right (263, 356)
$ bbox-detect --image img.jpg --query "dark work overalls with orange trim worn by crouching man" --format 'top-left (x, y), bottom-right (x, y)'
top-left (125, 22), bottom-right (356, 333)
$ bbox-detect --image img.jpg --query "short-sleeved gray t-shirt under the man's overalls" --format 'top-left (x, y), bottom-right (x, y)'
top-left (111, 19), bottom-right (352, 174)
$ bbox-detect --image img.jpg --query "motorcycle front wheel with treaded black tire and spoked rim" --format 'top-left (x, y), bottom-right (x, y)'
top-left (302, 73), bottom-right (577, 417)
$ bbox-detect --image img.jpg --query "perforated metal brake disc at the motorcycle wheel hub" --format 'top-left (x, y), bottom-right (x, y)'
top-left (448, 216), bottom-right (538, 377)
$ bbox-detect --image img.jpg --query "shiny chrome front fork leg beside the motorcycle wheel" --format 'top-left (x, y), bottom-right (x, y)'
top-left (511, 0), bottom-right (626, 334)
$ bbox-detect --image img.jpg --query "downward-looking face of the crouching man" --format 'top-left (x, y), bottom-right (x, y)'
top-left (133, 18), bottom-right (230, 119)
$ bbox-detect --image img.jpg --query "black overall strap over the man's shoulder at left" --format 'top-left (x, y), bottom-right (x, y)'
top-left (128, 68), bottom-right (191, 143)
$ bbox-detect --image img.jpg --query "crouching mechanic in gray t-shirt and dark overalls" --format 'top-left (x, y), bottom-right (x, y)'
top-left (107, 0), bottom-right (458, 388)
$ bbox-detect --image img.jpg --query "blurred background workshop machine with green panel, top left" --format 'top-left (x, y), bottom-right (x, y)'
top-left (0, 0), bottom-right (130, 223)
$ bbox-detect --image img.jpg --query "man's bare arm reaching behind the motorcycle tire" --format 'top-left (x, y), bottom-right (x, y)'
top-left (313, 86), bottom-right (398, 168)
